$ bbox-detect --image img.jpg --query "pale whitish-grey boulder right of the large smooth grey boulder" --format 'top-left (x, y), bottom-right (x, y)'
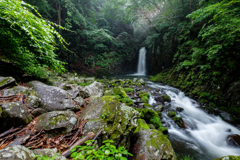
top-left (78, 81), bottom-right (104, 98)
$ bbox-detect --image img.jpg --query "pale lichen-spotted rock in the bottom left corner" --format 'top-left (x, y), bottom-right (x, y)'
top-left (0, 145), bottom-right (35, 160)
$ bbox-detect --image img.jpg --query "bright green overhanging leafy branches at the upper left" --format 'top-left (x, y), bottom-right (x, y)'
top-left (0, 0), bottom-right (66, 76)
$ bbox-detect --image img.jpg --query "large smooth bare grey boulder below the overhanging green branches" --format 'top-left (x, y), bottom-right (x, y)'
top-left (28, 81), bottom-right (75, 111)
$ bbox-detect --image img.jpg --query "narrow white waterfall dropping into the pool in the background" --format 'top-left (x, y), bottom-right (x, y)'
top-left (137, 47), bottom-right (147, 75)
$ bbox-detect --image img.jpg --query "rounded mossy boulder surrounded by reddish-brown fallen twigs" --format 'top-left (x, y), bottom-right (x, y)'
top-left (35, 111), bottom-right (77, 135)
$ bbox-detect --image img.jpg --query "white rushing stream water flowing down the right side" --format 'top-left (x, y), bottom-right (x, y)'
top-left (148, 82), bottom-right (240, 160)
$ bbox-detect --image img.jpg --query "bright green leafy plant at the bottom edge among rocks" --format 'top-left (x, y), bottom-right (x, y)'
top-left (71, 140), bottom-right (132, 160)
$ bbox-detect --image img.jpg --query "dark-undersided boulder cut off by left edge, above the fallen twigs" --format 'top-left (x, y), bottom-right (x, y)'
top-left (0, 102), bottom-right (32, 131)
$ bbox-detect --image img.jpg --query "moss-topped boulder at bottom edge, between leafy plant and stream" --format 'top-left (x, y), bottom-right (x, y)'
top-left (134, 129), bottom-right (176, 160)
